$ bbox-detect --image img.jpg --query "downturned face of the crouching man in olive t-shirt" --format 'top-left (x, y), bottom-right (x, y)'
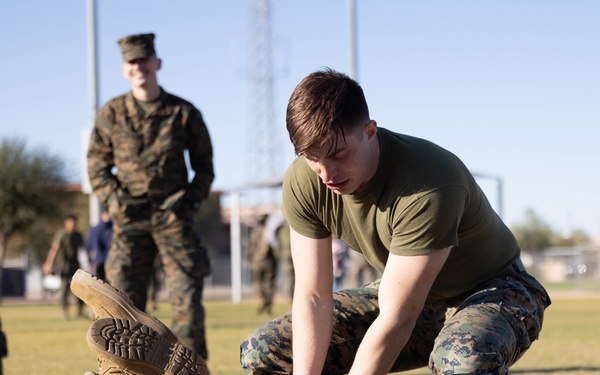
top-left (303, 120), bottom-right (379, 195)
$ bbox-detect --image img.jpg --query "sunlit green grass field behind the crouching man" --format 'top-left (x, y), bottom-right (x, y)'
top-left (0, 296), bottom-right (600, 375)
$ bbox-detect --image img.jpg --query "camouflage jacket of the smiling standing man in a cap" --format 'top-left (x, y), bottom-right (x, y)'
top-left (87, 89), bottom-right (214, 207)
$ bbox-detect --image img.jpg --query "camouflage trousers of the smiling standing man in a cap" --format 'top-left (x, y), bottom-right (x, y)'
top-left (105, 198), bottom-right (208, 359)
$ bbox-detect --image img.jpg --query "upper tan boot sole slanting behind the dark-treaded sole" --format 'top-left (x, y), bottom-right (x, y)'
top-left (71, 269), bottom-right (178, 342)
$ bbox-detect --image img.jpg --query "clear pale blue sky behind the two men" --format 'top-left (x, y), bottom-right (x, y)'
top-left (0, 0), bottom-right (600, 235)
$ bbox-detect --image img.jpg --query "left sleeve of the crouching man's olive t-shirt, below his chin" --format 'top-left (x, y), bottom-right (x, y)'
top-left (282, 157), bottom-right (330, 239)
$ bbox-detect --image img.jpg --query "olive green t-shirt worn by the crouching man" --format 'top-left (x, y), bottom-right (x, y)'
top-left (282, 128), bottom-right (520, 298)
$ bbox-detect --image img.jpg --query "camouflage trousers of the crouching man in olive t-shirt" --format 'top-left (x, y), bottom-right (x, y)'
top-left (240, 266), bottom-right (550, 375)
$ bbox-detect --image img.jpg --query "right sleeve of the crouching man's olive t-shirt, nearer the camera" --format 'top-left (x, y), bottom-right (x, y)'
top-left (390, 186), bottom-right (468, 255)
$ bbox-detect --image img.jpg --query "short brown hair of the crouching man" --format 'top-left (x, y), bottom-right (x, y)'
top-left (286, 68), bottom-right (370, 155)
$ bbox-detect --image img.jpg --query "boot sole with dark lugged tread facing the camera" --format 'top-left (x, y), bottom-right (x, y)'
top-left (86, 318), bottom-right (209, 375)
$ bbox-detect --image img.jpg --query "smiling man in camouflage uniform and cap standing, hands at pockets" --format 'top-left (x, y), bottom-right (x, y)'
top-left (88, 34), bottom-right (214, 358)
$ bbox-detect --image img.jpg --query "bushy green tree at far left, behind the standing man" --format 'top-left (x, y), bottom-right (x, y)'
top-left (0, 138), bottom-right (66, 297)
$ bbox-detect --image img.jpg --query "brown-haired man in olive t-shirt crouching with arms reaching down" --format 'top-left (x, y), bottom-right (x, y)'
top-left (240, 70), bottom-right (550, 375)
